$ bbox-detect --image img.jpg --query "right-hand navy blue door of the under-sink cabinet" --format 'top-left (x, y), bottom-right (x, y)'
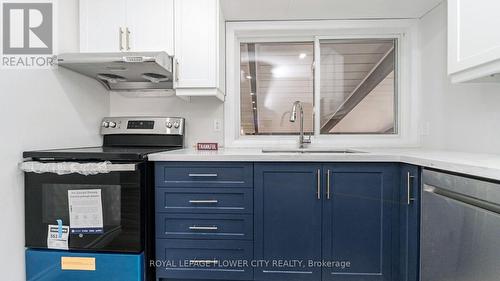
top-left (322, 163), bottom-right (399, 281)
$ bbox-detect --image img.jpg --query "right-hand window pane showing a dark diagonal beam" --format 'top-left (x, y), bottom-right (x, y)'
top-left (320, 39), bottom-right (397, 134)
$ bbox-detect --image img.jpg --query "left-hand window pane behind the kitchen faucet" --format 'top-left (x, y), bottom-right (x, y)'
top-left (240, 42), bottom-right (314, 135)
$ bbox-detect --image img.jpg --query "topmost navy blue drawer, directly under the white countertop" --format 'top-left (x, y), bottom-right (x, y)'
top-left (156, 162), bottom-right (253, 188)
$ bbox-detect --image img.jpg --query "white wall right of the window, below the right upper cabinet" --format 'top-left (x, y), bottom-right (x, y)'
top-left (420, 4), bottom-right (500, 153)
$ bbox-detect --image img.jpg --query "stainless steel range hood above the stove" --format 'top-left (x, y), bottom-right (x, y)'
top-left (57, 52), bottom-right (173, 91)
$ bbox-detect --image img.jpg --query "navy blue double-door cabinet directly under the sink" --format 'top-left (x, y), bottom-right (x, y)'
top-left (254, 163), bottom-right (400, 281)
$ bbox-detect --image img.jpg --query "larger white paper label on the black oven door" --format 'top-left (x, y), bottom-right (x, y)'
top-left (68, 189), bottom-right (103, 234)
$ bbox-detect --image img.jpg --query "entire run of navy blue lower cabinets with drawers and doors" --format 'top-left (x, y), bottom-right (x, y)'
top-left (156, 162), bottom-right (420, 281)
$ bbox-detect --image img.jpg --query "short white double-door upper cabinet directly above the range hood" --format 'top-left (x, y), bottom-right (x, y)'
top-left (80, 0), bottom-right (174, 55)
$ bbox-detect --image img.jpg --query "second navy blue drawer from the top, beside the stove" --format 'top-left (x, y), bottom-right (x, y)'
top-left (156, 188), bottom-right (253, 214)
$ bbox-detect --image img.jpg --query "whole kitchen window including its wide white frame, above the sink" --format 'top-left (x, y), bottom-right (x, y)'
top-left (224, 20), bottom-right (421, 147)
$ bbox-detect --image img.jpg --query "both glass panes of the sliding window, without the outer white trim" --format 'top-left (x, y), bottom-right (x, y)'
top-left (240, 39), bottom-right (397, 135)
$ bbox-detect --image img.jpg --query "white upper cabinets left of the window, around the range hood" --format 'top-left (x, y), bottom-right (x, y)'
top-left (80, 0), bottom-right (225, 100)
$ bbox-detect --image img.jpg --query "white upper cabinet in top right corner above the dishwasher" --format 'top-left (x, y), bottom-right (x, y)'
top-left (448, 0), bottom-right (500, 83)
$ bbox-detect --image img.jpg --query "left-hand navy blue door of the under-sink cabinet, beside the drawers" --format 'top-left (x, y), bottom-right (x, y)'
top-left (254, 163), bottom-right (322, 281)
